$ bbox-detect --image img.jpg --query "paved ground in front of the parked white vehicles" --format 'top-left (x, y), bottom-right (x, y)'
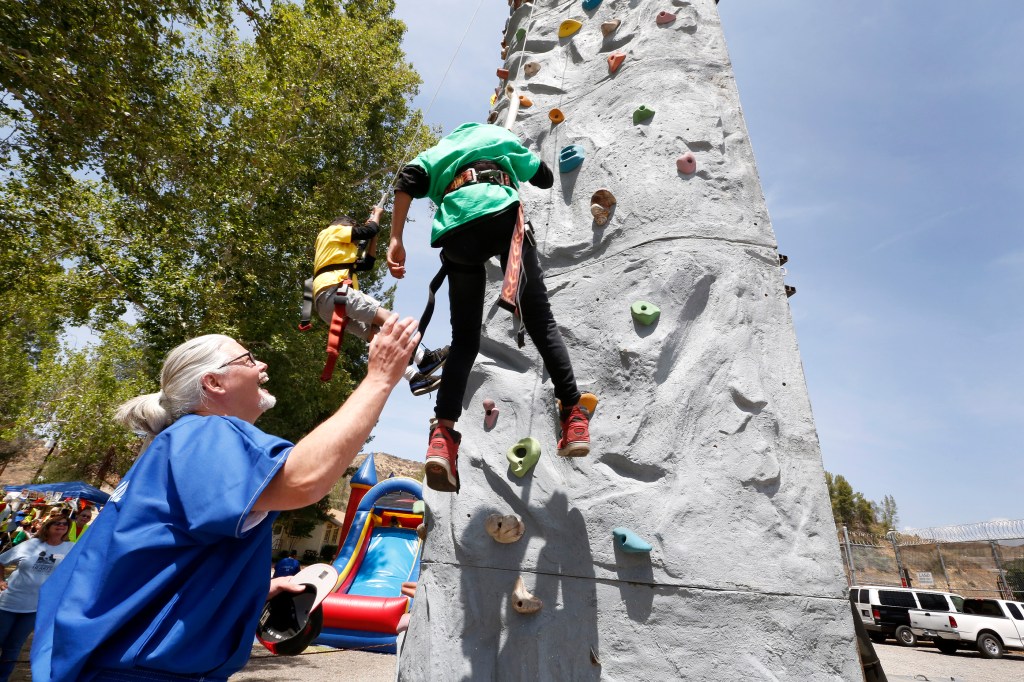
top-left (874, 642), bottom-right (1024, 682)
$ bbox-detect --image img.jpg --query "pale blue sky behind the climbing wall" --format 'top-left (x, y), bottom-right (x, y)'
top-left (369, 0), bottom-right (1024, 528)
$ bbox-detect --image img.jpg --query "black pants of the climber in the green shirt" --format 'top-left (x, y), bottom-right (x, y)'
top-left (434, 204), bottom-right (580, 421)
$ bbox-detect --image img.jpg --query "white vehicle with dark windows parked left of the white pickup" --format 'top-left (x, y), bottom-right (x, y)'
top-left (850, 585), bottom-right (964, 646)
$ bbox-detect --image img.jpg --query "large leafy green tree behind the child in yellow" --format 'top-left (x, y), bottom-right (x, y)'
top-left (0, 0), bottom-right (433, 503)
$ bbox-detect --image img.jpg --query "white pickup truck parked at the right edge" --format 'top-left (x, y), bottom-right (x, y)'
top-left (909, 599), bottom-right (1024, 658)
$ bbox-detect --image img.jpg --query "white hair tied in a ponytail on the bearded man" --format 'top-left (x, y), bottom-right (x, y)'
top-left (114, 334), bottom-right (233, 443)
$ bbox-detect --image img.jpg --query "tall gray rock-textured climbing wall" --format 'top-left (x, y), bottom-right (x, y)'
top-left (398, 0), bottom-right (861, 681)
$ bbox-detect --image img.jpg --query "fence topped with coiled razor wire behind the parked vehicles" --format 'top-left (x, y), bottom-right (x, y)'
top-left (837, 520), bottom-right (1024, 601)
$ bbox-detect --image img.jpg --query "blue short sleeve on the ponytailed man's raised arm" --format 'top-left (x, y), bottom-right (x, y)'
top-left (169, 417), bottom-right (292, 540)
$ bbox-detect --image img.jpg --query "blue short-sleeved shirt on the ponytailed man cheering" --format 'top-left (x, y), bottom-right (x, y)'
top-left (32, 415), bottom-right (292, 680)
